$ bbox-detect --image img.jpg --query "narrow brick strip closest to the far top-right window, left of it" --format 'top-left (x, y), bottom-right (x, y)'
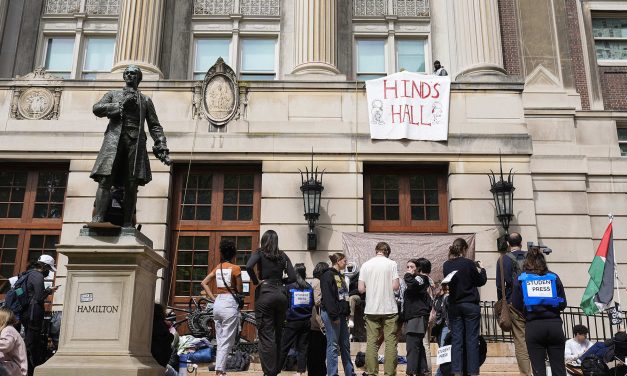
top-left (566, 0), bottom-right (590, 110)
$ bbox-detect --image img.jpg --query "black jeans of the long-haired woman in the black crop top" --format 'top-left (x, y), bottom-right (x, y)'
top-left (255, 281), bottom-right (287, 376)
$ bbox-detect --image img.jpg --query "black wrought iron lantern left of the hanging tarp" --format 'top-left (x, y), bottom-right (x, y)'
top-left (298, 150), bottom-right (324, 251)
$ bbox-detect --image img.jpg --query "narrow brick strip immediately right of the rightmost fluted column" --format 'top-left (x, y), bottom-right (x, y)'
top-left (499, 0), bottom-right (522, 76)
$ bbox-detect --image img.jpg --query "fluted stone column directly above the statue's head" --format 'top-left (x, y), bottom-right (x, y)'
top-left (111, 0), bottom-right (165, 77)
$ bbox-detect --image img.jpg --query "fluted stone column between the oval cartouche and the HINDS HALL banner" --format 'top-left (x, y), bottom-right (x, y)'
top-left (292, 0), bottom-right (340, 74)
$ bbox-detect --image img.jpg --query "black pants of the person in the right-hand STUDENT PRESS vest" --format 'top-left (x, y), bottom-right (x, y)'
top-left (525, 319), bottom-right (566, 376)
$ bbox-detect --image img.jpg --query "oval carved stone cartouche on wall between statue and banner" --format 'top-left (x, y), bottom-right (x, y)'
top-left (202, 58), bottom-right (239, 126)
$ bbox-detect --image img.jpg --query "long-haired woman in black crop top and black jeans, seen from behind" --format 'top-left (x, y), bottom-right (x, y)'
top-left (246, 230), bottom-right (296, 376)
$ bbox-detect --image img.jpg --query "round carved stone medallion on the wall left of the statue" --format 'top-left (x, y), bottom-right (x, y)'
top-left (10, 68), bottom-right (63, 120)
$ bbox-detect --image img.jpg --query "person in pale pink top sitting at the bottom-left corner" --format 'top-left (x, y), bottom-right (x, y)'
top-left (0, 308), bottom-right (28, 376)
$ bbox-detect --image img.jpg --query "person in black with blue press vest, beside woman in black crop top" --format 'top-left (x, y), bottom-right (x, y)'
top-left (279, 263), bottom-right (314, 376)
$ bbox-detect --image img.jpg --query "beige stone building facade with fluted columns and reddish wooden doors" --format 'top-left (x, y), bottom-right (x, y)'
top-left (0, 0), bottom-right (627, 314)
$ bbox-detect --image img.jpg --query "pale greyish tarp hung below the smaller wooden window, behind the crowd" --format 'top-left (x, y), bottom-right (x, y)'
top-left (342, 232), bottom-right (475, 281)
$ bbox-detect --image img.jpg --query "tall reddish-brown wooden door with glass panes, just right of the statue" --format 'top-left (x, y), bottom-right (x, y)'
top-left (170, 166), bottom-right (261, 304)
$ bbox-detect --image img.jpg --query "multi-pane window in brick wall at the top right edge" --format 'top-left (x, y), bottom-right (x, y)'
top-left (592, 17), bottom-right (627, 63)
